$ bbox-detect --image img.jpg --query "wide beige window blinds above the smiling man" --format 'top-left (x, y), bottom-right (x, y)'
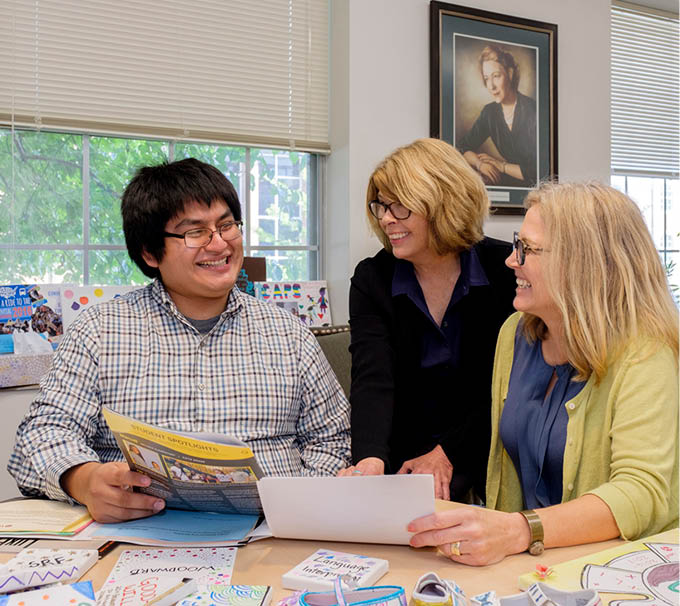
top-left (0, 0), bottom-right (329, 152)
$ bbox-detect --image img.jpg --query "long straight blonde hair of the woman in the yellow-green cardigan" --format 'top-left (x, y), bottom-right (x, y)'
top-left (524, 183), bottom-right (678, 382)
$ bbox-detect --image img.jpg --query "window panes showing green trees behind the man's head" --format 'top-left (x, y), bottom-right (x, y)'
top-left (0, 129), bottom-right (320, 284)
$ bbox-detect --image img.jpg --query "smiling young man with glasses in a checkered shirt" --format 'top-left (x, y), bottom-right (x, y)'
top-left (8, 159), bottom-right (349, 522)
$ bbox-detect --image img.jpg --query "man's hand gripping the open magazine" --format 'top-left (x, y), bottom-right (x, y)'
top-left (61, 461), bottom-right (165, 523)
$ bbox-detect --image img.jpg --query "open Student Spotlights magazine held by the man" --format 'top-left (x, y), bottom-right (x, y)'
top-left (103, 407), bottom-right (264, 514)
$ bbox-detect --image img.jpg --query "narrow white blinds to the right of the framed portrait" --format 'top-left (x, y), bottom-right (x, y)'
top-left (611, 3), bottom-right (680, 176)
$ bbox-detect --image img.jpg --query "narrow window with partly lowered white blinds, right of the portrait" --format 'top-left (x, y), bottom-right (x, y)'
top-left (611, 2), bottom-right (680, 300)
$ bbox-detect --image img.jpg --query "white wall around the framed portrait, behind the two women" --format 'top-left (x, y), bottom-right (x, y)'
top-left (324, 0), bottom-right (610, 323)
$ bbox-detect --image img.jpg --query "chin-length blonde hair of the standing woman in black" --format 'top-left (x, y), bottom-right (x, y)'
top-left (366, 139), bottom-right (489, 255)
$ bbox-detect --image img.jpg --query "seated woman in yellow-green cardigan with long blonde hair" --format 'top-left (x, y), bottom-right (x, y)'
top-left (410, 183), bottom-right (678, 564)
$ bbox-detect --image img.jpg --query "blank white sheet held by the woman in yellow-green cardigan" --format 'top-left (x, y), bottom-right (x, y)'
top-left (257, 474), bottom-right (434, 545)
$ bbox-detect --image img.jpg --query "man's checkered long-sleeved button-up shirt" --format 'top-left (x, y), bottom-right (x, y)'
top-left (7, 281), bottom-right (350, 500)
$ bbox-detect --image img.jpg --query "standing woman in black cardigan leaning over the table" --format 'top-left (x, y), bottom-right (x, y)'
top-left (342, 139), bottom-right (514, 500)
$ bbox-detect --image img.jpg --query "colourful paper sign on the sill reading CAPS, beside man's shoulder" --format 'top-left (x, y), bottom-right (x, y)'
top-left (255, 280), bottom-right (332, 326)
